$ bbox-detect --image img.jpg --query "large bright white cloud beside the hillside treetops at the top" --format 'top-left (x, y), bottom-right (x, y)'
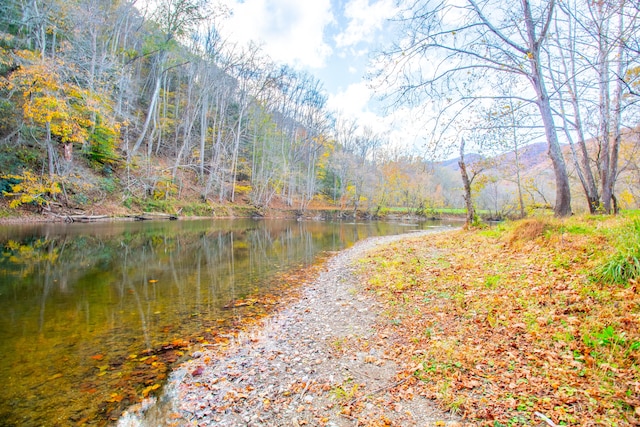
top-left (221, 0), bottom-right (334, 68)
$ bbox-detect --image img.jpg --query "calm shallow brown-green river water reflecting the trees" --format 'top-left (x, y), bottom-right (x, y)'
top-left (0, 220), bottom-right (456, 426)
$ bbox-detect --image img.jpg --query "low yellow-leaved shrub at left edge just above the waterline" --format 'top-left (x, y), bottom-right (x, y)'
top-left (0, 171), bottom-right (62, 209)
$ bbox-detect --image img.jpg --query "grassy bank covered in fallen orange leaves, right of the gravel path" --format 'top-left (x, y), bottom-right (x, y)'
top-left (361, 215), bottom-right (640, 426)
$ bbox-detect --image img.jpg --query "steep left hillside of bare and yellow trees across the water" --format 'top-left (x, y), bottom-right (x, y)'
top-left (0, 0), bottom-right (456, 216)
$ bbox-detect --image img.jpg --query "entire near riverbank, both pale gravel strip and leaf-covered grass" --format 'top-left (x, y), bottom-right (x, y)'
top-left (120, 217), bottom-right (640, 427)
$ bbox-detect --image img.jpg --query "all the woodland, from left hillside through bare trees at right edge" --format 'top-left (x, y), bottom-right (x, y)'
top-left (0, 0), bottom-right (640, 221)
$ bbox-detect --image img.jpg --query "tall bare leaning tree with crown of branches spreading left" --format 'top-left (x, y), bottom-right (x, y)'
top-left (377, 0), bottom-right (571, 216)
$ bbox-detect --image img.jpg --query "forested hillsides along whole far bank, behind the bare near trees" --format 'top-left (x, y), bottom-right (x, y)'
top-left (0, 0), bottom-right (639, 221)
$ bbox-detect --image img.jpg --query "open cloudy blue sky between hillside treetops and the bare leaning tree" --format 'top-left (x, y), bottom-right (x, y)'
top-left (215, 0), bottom-right (420, 142)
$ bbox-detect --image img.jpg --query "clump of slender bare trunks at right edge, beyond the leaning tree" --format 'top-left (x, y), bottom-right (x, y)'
top-left (547, 0), bottom-right (640, 213)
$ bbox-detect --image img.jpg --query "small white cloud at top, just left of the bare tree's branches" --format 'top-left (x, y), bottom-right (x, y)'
top-left (335, 0), bottom-right (397, 47)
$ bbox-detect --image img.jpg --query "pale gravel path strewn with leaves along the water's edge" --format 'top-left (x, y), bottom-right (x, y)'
top-left (118, 232), bottom-right (461, 427)
